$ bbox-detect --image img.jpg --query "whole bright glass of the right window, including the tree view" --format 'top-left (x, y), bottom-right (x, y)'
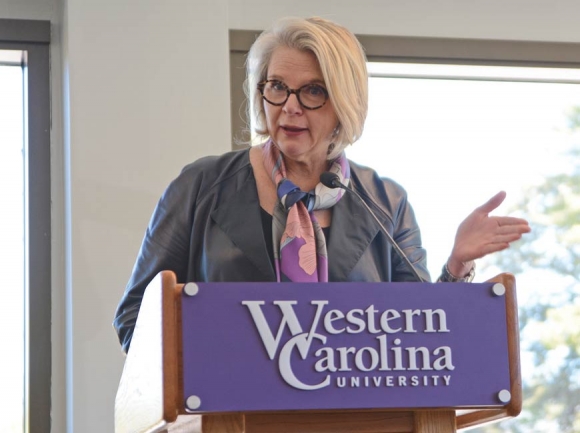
top-left (354, 62), bottom-right (580, 432)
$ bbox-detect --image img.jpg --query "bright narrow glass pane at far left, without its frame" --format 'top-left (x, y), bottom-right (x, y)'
top-left (0, 51), bottom-right (25, 432)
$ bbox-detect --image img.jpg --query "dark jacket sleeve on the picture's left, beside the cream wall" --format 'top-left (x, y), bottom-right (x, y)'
top-left (113, 167), bottom-right (196, 352)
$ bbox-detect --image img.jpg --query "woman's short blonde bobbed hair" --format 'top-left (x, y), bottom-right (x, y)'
top-left (244, 17), bottom-right (368, 159)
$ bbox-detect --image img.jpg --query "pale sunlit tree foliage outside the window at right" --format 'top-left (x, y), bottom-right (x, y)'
top-left (473, 106), bottom-right (580, 433)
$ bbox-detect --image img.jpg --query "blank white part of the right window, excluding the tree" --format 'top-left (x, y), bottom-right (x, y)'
top-left (347, 62), bottom-right (580, 277)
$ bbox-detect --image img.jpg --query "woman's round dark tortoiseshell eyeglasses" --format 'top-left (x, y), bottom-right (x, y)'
top-left (258, 80), bottom-right (328, 110)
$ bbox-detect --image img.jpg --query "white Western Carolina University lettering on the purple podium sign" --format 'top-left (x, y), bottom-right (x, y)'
top-left (242, 300), bottom-right (455, 390)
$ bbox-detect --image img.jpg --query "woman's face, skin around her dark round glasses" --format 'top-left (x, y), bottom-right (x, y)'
top-left (263, 47), bottom-right (338, 165)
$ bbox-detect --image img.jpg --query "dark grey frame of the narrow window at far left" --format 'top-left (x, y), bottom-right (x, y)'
top-left (0, 19), bottom-right (52, 433)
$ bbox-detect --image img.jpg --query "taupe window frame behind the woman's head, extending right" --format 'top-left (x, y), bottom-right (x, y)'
top-left (229, 29), bottom-right (580, 150)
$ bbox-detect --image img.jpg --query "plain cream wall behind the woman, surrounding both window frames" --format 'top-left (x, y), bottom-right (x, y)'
top-left (0, 0), bottom-right (580, 433)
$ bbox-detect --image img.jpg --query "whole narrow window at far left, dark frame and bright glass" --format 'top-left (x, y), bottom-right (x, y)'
top-left (0, 20), bottom-right (51, 433)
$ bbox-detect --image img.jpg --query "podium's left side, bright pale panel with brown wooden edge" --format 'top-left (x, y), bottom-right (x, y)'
top-left (115, 271), bottom-right (183, 433)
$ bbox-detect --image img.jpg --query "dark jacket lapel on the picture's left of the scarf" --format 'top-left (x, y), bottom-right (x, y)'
top-left (211, 170), bottom-right (276, 281)
